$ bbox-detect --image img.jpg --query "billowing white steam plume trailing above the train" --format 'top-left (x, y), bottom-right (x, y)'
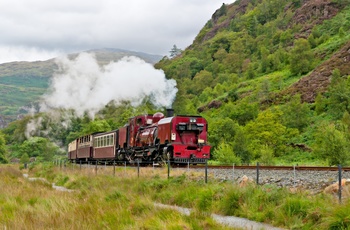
top-left (41, 53), bottom-right (177, 117)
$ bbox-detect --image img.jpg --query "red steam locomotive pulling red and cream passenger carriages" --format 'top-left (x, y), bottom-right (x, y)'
top-left (68, 109), bottom-right (211, 164)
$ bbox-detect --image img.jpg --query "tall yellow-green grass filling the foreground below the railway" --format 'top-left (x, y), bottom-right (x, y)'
top-left (0, 165), bottom-right (350, 229)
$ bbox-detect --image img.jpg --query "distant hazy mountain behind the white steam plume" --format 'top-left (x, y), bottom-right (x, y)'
top-left (0, 48), bottom-right (162, 128)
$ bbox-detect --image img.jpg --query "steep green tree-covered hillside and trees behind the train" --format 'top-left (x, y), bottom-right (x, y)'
top-left (0, 0), bottom-right (350, 165)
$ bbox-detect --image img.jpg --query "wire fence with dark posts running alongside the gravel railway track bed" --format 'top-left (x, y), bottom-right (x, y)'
top-left (50, 160), bottom-right (350, 203)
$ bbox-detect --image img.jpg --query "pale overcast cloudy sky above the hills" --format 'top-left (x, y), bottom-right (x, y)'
top-left (0, 0), bottom-right (233, 63)
